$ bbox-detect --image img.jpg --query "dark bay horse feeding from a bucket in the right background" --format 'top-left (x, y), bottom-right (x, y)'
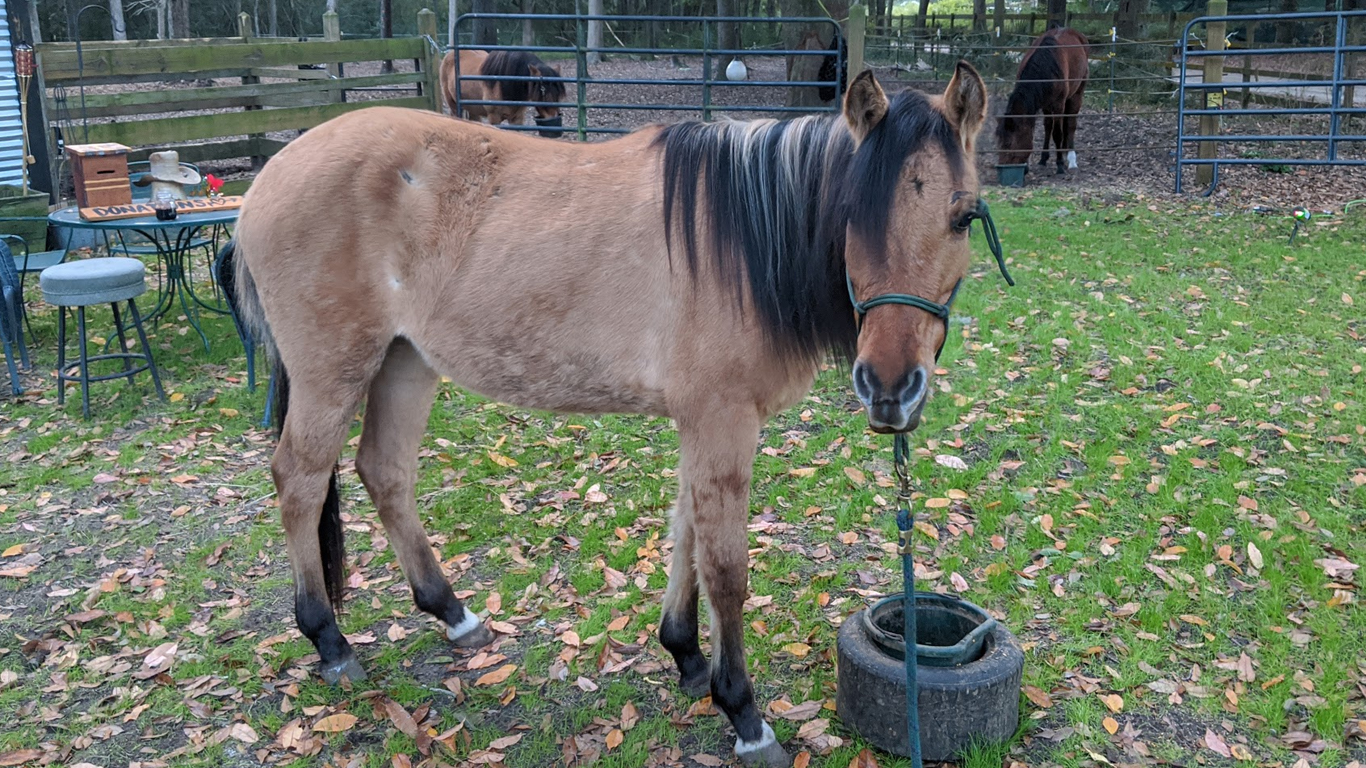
top-left (996, 27), bottom-right (1090, 174)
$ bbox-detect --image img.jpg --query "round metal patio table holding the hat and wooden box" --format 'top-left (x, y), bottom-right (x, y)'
top-left (48, 208), bottom-right (238, 350)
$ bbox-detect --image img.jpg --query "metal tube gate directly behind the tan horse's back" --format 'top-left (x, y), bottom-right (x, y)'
top-left (447, 14), bottom-right (844, 141)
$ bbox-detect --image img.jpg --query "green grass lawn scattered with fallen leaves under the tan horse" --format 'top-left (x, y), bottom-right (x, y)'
top-left (0, 193), bottom-right (1366, 768)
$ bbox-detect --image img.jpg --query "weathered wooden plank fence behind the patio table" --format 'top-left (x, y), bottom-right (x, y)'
top-left (37, 10), bottom-right (441, 196)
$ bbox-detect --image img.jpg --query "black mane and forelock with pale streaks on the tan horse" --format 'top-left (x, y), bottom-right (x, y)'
top-left (654, 90), bottom-right (966, 358)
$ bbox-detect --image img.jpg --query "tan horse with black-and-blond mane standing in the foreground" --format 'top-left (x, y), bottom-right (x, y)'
top-left (224, 63), bottom-right (986, 765)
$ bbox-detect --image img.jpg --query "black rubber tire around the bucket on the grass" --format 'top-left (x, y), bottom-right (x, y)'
top-left (835, 604), bottom-right (1025, 761)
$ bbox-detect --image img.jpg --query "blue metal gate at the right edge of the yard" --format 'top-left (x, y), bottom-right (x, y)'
top-left (1176, 11), bottom-right (1366, 191)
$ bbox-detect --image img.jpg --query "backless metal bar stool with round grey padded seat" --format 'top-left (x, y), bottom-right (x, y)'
top-left (38, 257), bottom-right (167, 418)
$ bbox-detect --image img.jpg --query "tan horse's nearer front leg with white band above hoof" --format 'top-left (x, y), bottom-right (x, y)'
top-left (675, 410), bottom-right (791, 768)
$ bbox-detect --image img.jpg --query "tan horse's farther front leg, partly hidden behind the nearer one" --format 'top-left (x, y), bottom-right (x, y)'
top-left (660, 488), bottom-right (712, 697)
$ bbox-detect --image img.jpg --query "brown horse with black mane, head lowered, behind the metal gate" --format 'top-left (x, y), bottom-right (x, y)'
top-left (441, 51), bottom-right (564, 138)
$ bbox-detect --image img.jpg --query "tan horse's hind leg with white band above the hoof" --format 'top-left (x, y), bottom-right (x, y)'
top-left (355, 339), bottom-right (493, 648)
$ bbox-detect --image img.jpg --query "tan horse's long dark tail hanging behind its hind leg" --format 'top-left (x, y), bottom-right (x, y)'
top-left (216, 236), bottom-right (346, 611)
